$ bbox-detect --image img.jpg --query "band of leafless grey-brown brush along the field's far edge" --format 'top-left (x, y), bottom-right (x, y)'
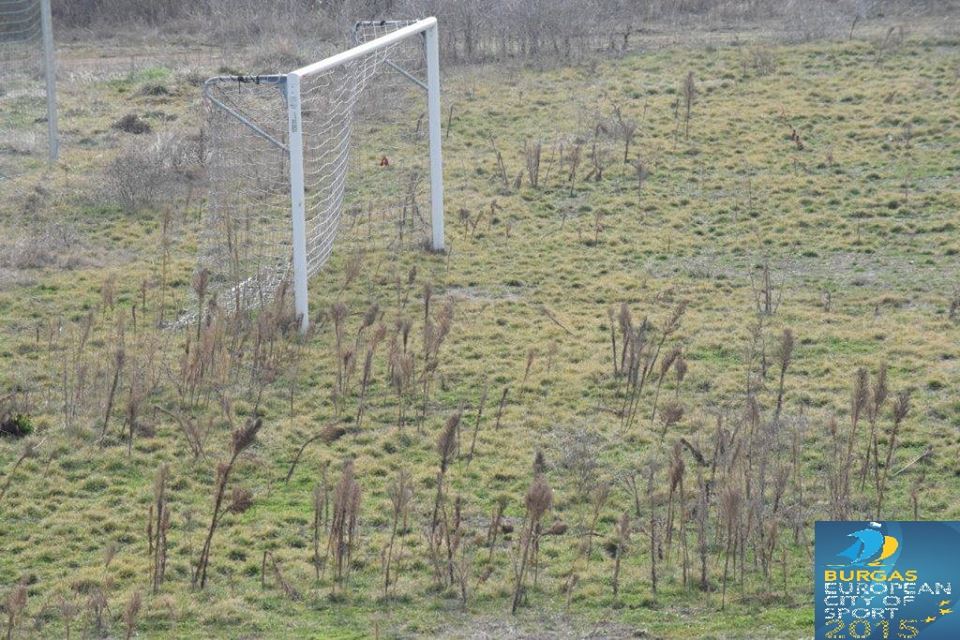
top-left (53, 0), bottom-right (955, 62)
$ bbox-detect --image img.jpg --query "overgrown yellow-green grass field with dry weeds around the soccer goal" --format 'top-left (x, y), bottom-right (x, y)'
top-left (0, 28), bottom-right (960, 639)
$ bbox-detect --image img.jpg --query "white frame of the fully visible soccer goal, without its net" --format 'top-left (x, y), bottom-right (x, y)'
top-left (203, 17), bottom-right (444, 332)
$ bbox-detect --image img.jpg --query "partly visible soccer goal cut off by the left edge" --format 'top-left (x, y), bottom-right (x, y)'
top-left (0, 0), bottom-right (59, 180)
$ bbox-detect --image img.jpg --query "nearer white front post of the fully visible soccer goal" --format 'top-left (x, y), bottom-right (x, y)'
top-left (286, 73), bottom-right (310, 333)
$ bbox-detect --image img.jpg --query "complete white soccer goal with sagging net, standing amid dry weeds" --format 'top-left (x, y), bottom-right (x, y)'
top-left (199, 18), bottom-right (444, 330)
